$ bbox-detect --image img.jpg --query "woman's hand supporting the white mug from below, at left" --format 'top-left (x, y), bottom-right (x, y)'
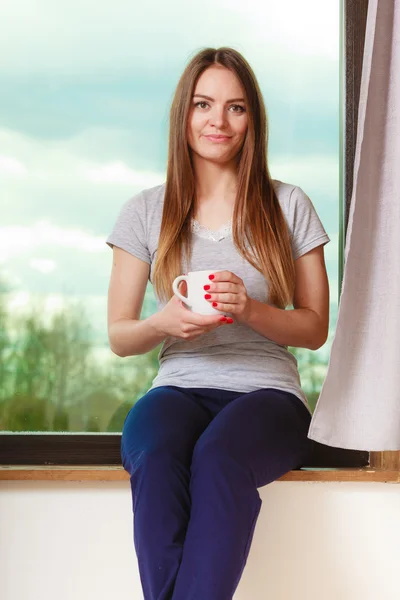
top-left (152, 296), bottom-right (233, 341)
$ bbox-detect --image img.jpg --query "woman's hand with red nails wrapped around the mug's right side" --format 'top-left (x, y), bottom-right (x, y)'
top-left (204, 271), bottom-right (251, 322)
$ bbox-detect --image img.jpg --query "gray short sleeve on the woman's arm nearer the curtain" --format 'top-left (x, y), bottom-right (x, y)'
top-left (288, 187), bottom-right (330, 260)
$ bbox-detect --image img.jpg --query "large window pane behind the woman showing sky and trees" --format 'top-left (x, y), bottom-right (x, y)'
top-left (0, 0), bottom-right (340, 432)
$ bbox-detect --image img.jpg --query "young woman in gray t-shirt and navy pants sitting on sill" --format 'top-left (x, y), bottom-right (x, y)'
top-left (107, 48), bottom-right (329, 600)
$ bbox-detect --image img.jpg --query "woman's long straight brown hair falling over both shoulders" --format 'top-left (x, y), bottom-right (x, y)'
top-left (153, 47), bottom-right (295, 308)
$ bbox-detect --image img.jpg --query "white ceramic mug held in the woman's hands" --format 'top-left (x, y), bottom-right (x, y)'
top-left (172, 269), bottom-right (225, 315)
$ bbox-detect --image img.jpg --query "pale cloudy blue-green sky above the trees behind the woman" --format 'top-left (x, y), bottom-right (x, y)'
top-left (0, 0), bottom-right (339, 342)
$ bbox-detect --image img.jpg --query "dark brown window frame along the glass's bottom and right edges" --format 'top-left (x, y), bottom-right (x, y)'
top-left (0, 0), bottom-right (394, 469)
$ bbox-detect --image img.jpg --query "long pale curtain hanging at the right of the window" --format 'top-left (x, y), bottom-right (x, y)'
top-left (309, 0), bottom-right (400, 451)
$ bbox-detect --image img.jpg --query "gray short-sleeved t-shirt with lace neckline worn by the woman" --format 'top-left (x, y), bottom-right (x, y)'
top-left (107, 180), bottom-right (329, 408)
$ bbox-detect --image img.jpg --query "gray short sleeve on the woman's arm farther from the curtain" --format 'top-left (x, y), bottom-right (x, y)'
top-left (106, 193), bottom-right (151, 264)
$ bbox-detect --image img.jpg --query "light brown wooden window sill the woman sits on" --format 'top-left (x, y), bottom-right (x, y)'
top-left (0, 465), bottom-right (400, 483)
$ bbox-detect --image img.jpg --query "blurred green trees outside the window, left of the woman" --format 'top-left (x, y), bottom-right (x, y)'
top-left (0, 288), bottom-right (158, 432)
